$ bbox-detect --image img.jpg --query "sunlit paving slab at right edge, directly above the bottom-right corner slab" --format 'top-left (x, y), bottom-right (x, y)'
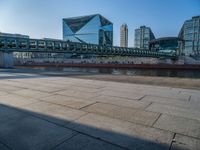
top-left (154, 114), bottom-right (200, 138)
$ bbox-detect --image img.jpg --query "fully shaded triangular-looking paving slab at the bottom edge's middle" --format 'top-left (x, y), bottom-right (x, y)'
top-left (54, 134), bottom-right (125, 150)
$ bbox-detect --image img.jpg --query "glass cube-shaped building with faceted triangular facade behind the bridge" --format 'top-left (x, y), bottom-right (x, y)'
top-left (63, 14), bottom-right (113, 46)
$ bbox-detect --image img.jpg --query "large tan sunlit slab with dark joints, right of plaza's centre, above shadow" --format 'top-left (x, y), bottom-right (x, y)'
top-left (81, 103), bottom-right (160, 126)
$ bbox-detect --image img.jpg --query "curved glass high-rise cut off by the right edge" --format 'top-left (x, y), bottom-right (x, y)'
top-left (179, 16), bottom-right (200, 56)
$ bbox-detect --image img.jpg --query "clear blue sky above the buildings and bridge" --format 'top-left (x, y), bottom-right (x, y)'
top-left (0, 0), bottom-right (200, 47)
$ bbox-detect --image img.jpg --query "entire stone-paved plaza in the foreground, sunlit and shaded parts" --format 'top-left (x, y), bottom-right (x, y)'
top-left (0, 71), bottom-right (200, 150)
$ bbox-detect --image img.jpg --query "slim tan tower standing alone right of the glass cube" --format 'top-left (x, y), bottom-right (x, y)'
top-left (120, 24), bottom-right (128, 47)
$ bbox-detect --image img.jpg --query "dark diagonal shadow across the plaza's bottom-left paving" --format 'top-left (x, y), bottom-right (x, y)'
top-left (0, 104), bottom-right (177, 150)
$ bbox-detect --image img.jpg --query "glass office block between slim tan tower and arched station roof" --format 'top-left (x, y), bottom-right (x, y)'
top-left (135, 26), bottom-right (155, 49)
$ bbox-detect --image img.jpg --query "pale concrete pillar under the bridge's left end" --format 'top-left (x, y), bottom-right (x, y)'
top-left (0, 52), bottom-right (14, 68)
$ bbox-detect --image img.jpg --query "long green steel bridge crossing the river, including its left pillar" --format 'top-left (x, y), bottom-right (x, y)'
top-left (0, 36), bottom-right (177, 67)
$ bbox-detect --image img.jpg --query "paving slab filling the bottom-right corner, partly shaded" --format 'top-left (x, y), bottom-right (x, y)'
top-left (171, 134), bottom-right (200, 150)
